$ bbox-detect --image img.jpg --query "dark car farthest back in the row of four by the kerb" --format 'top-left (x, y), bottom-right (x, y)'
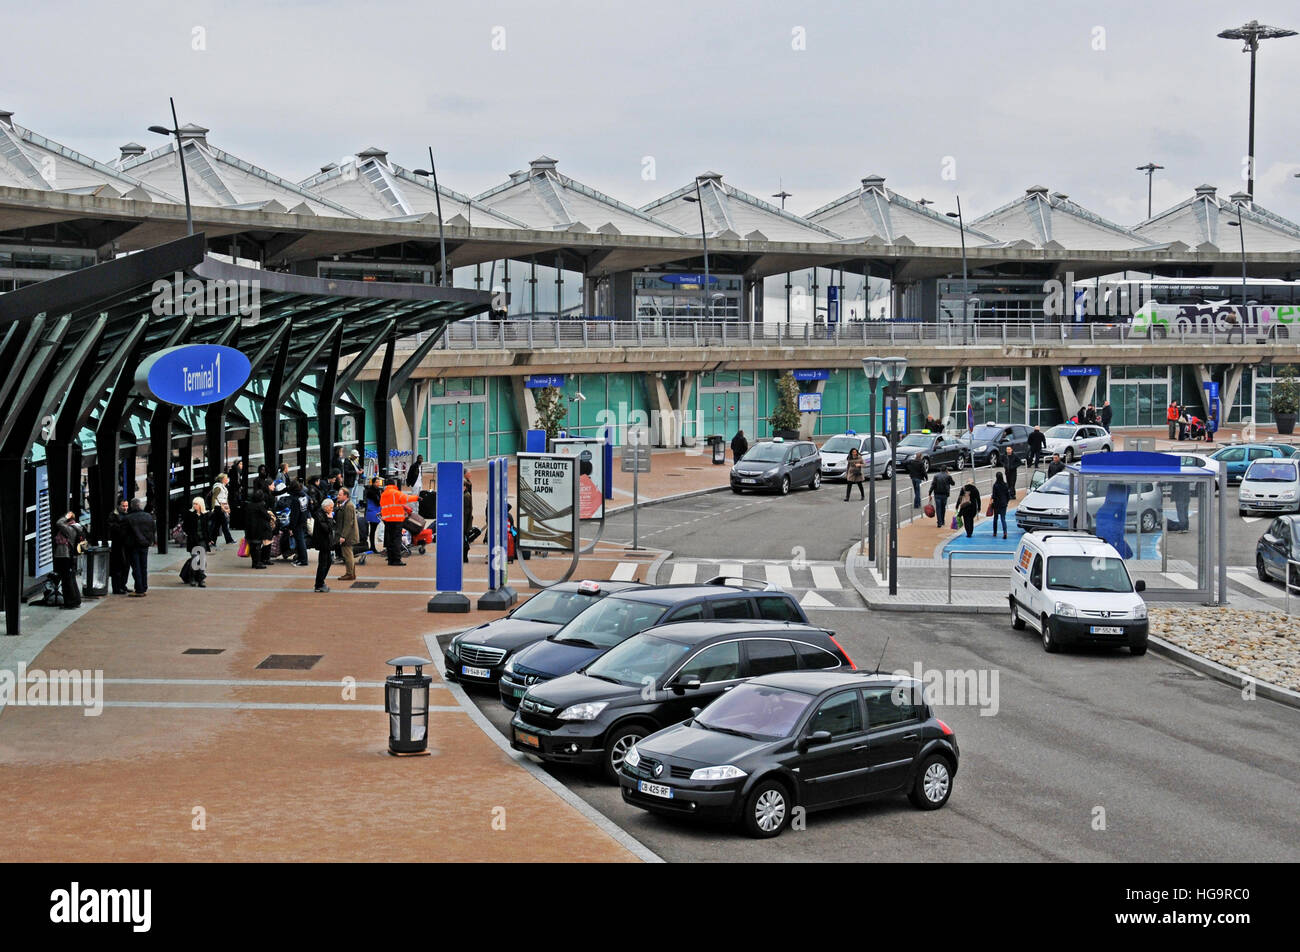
top-left (442, 580), bottom-right (641, 684)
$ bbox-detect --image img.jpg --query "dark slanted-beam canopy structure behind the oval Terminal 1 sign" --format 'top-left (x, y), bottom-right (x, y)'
top-left (0, 234), bottom-right (491, 635)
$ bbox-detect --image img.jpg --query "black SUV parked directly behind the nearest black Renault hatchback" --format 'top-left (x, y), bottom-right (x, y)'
top-left (510, 622), bottom-right (853, 780)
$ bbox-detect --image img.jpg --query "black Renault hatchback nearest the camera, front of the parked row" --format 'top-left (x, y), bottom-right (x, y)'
top-left (619, 671), bottom-right (959, 836)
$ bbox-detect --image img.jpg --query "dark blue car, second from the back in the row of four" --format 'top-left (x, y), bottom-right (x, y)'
top-left (498, 577), bottom-right (809, 710)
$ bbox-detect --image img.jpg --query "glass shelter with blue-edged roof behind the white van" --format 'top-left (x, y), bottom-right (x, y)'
top-left (1066, 451), bottom-right (1227, 605)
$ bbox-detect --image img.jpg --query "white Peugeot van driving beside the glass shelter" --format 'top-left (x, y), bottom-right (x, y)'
top-left (1008, 532), bottom-right (1147, 654)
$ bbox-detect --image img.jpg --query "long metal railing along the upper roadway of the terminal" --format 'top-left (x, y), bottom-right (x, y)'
top-left (403, 319), bottom-right (1297, 350)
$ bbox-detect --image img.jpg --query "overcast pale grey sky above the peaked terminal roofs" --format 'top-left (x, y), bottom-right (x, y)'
top-left (10, 0), bottom-right (1300, 224)
